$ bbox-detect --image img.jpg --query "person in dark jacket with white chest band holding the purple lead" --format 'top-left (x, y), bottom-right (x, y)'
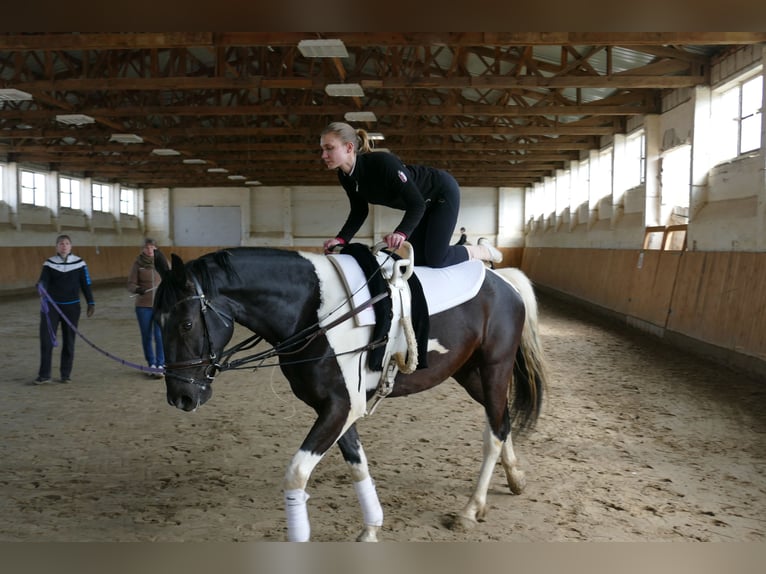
top-left (35, 235), bottom-right (96, 385)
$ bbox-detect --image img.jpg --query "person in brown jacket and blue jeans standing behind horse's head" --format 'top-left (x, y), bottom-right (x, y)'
top-left (128, 237), bottom-right (165, 379)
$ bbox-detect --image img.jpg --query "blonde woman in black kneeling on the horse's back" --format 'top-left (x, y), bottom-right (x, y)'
top-left (320, 122), bottom-right (503, 267)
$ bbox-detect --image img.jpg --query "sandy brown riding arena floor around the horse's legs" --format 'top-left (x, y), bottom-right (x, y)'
top-left (0, 286), bottom-right (766, 542)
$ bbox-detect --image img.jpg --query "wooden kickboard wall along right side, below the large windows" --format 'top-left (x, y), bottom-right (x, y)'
top-left (522, 248), bottom-right (766, 366)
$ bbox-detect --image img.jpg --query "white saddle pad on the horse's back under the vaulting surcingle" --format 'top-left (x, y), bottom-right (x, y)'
top-left (328, 253), bottom-right (487, 326)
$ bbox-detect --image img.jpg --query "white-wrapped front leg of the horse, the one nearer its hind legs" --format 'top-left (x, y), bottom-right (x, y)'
top-left (338, 425), bottom-right (383, 542)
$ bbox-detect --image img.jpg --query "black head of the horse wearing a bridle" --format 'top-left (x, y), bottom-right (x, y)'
top-left (154, 254), bottom-right (234, 411)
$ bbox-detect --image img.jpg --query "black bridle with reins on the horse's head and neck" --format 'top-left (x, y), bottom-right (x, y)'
top-left (165, 273), bottom-right (390, 390)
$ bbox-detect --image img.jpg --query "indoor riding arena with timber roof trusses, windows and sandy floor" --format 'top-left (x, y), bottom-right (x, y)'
top-left (0, 32), bottom-right (766, 543)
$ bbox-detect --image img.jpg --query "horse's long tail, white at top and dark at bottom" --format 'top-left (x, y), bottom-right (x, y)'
top-left (496, 267), bottom-right (548, 432)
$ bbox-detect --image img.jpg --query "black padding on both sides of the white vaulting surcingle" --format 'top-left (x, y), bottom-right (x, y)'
top-left (341, 243), bottom-right (430, 371)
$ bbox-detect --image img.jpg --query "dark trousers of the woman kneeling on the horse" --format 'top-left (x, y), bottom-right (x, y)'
top-left (407, 172), bottom-right (468, 267)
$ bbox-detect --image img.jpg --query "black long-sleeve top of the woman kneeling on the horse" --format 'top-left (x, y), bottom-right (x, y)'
top-left (337, 151), bottom-right (450, 243)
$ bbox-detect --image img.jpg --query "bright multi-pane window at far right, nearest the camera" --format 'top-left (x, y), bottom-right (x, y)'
top-left (712, 75), bottom-right (763, 163)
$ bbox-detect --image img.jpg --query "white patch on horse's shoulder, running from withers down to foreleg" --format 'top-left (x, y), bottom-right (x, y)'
top-left (300, 252), bottom-right (381, 424)
